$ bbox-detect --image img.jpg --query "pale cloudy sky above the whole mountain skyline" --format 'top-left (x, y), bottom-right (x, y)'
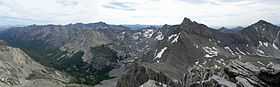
top-left (0, 0), bottom-right (280, 27)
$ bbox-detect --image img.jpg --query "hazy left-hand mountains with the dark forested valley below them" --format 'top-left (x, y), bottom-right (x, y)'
top-left (0, 22), bottom-right (160, 85)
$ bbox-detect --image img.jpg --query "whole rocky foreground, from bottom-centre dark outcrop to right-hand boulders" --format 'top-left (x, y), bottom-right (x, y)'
top-left (117, 60), bottom-right (280, 87)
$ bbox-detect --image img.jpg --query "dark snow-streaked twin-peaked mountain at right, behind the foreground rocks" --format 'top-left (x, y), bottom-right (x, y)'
top-left (138, 18), bottom-right (280, 79)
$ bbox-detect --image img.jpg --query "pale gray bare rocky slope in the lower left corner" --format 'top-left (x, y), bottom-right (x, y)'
top-left (0, 45), bottom-right (70, 87)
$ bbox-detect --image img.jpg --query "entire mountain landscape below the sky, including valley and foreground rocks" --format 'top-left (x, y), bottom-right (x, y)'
top-left (0, 18), bottom-right (280, 87)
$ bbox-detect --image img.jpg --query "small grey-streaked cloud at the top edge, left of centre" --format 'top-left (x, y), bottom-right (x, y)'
top-left (103, 2), bottom-right (136, 11)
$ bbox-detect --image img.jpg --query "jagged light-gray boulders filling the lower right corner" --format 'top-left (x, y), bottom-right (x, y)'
top-left (180, 60), bottom-right (279, 87)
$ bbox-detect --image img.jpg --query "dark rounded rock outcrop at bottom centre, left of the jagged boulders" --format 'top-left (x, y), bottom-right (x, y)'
top-left (117, 64), bottom-right (177, 87)
